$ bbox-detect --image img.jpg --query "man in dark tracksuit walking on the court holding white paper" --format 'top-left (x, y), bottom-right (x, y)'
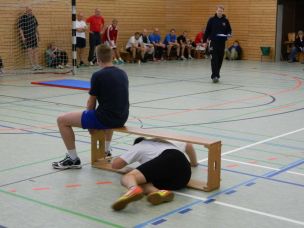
top-left (203, 5), bottom-right (231, 83)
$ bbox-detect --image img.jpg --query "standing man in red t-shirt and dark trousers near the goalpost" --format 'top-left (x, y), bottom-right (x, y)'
top-left (86, 9), bottom-right (104, 65)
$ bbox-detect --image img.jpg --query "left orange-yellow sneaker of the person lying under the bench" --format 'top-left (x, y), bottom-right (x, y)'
top-left (112, 186), bottom-right (144, 211)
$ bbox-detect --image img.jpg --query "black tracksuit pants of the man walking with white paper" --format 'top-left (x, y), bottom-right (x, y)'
top-left (210, 40), bottom-right (225, 79)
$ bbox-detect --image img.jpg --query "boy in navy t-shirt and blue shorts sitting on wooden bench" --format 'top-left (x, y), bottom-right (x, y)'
top-left (52, 44), bottom-right (129, 169)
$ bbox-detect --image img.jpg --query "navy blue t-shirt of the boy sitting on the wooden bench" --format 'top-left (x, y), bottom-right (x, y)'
top-left (89, 66), bottom-right (129, 128)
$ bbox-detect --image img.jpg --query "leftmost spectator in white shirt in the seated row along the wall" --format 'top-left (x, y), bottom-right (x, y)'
top-left (126, 32), bottom-right (145, 63)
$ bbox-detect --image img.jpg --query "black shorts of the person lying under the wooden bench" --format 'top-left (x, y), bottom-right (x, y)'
top-left (136, 149), bottom-right (191, 190)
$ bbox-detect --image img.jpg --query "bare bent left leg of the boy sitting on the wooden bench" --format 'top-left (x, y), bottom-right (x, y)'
top-left (57, 112), bottom-right (82, 150)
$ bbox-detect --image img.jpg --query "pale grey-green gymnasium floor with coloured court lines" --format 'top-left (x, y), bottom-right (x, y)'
top-left (0, 60), bottom-right (304, 228)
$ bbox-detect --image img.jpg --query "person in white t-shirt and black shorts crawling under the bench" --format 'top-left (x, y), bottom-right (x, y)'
top-left (112, 137), bottom-right (197, 211)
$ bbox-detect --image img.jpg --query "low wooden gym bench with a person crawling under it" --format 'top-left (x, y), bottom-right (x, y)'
top-left (91, 127), bottom-right (221, 192)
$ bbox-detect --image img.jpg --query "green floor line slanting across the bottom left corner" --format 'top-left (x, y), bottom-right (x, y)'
top-left (0, 189), bottom-right (124, 228)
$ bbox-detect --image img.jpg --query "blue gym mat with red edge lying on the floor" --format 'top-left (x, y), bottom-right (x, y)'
top-left (31, 79), bottom-right (91, 90)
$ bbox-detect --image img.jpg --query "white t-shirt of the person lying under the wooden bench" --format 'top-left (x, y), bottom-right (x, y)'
top-left (120, 140), bottom-right (186, 164)
